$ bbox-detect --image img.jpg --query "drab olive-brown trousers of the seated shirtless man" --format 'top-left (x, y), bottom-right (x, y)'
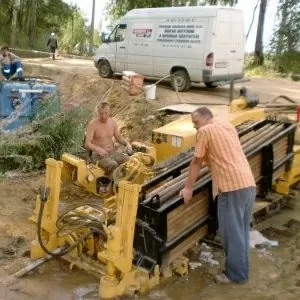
top-left (92, 151), bottom-right (129, 174)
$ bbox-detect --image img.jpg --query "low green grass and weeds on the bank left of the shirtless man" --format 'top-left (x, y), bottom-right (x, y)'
top-left (0, 98), bottom-right (90, 173)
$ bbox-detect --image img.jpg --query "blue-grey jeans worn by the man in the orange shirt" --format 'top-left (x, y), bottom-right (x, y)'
top-left (218, 187), bottom-right (256, 282)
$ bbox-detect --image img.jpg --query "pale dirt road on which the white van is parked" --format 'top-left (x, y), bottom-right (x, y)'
top-left (24, 58), bottom-right (300, 103)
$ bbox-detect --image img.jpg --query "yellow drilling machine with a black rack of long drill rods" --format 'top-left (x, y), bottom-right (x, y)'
top-left (24, 91), bottom-right (300, 299)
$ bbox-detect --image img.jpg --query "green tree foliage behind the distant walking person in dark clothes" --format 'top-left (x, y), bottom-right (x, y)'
top-left (0, 0), bottom-right (100, 53)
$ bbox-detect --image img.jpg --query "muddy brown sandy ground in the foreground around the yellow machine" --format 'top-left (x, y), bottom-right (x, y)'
top-left (0, 175), bottom-right (300, 300)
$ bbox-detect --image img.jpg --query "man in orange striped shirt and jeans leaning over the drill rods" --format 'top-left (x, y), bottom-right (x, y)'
top-left (181, 107), bottom-right (256, 283)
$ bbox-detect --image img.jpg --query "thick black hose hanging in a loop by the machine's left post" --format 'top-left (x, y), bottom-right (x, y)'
top-left (37, 201), bottom-right (93, 257)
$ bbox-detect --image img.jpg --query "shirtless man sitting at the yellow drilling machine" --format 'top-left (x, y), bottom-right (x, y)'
top-left (85, 102), bottom-right (132, 174)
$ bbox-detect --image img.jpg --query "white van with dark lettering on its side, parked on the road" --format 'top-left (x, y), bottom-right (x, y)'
top-left (94, 6), bottom-right (245, 92)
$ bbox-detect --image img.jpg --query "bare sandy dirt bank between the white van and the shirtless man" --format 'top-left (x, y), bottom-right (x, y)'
top-left (26, 66), bottom-right (175, 141)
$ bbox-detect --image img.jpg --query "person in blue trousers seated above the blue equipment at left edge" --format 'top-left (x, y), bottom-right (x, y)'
top-left (0, 46), bottom-right (23, 80)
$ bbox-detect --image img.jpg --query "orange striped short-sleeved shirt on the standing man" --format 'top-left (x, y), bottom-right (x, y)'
top-left (194, 120), bottom-right (256, 197)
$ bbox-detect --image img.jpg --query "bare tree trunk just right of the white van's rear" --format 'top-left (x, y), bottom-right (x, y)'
top-left (254, 0), bottom-right (268, 66)
